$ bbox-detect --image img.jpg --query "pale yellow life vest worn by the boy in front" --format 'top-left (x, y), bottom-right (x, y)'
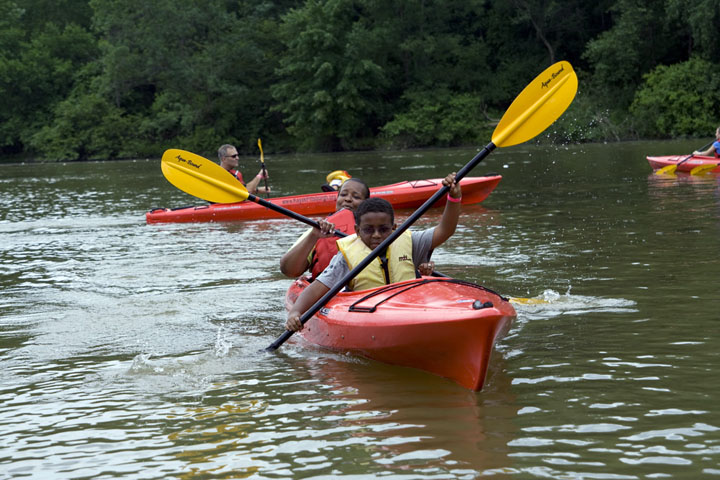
top-left (337, 231), bottom-right (415, 291)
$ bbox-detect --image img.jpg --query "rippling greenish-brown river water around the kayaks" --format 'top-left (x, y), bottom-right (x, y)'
top-left (0, 141), bottom-right (720, 479)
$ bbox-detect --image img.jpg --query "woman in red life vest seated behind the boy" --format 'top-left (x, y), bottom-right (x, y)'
top-left (280, 178), bottom-right (370, 280)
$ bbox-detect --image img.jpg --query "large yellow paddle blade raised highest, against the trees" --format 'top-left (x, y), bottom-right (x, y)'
top-left (492, 61), bottom-right (577, 147)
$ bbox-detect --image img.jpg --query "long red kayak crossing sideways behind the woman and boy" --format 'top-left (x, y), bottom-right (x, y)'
top-left (145, 175), bottom-right (502, 223)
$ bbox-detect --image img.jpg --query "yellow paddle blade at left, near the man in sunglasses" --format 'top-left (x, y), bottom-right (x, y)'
top-left (161, 148), bottom-right (248, 203)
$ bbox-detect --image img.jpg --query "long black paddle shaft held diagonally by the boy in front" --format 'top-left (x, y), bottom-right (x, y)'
top-left (268, 142), bottom-right (495, 352)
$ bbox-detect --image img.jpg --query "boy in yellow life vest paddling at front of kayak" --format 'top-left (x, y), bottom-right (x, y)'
top-left (285, 172), bottom-right (462, 331)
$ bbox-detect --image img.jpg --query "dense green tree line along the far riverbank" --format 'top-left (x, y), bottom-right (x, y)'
top-left (0, 0), bottom-right (720, 161)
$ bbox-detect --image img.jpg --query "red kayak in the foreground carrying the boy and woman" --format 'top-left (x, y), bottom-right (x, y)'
top-left (285, 277), bottom-right (516, 391)
